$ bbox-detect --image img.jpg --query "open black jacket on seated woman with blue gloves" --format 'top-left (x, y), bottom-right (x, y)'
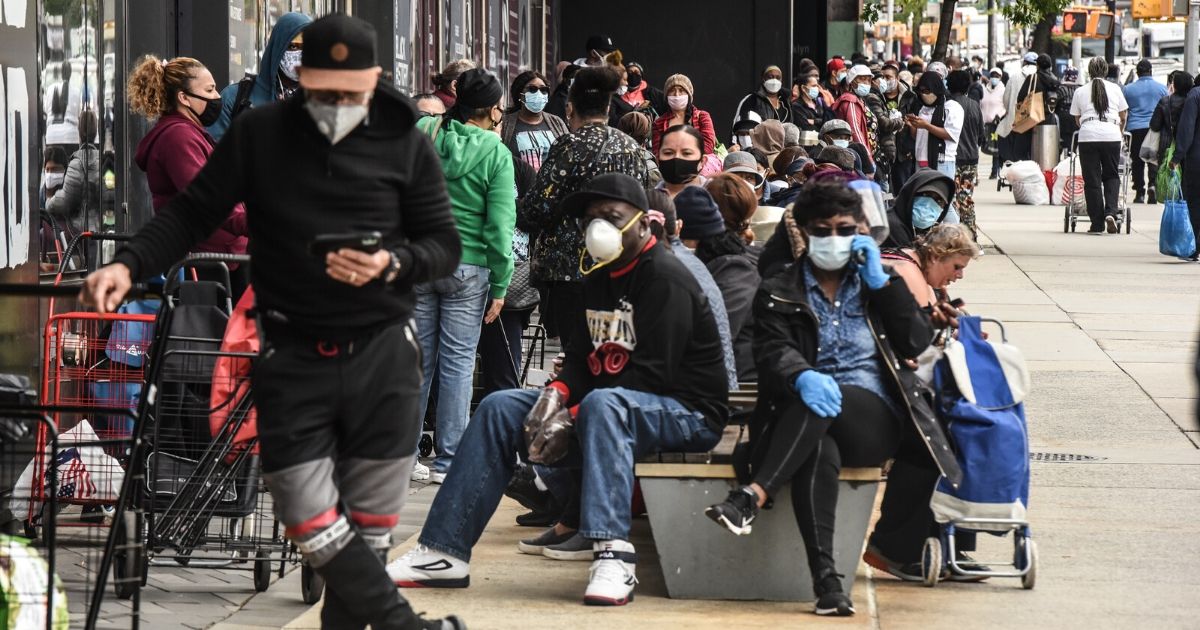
top-left (750, 257), bottom-right (962, 480)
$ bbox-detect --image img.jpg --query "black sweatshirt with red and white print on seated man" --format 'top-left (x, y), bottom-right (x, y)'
top-left (558, 238), bottom-right (730, 433)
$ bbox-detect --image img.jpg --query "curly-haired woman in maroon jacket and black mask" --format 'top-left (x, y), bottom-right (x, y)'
top-left (128, 55), bottom-right (247, 301)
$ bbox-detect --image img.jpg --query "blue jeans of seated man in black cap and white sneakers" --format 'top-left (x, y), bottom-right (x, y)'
top-left (419, 388), bottom-right (721, 562)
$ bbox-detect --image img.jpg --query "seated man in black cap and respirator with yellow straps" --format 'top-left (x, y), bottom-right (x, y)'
top-left (388, 173), bottom-right (728, 606)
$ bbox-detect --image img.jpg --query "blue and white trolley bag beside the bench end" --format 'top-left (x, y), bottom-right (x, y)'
top-left (930, 317), bottom-right (1030, 533)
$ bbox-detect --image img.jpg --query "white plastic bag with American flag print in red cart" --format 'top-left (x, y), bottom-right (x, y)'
top-left (8, 420), bottom-right (125, 521)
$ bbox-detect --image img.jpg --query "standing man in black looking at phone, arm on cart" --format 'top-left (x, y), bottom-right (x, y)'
top-left (80, 14), bottom-right (463, 630)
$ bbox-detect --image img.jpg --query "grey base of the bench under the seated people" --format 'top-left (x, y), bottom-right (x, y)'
top-left (640, 470), bottom-right (878, 601)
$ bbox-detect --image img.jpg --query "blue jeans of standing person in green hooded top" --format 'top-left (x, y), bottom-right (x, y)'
top-left (415, 264), bottom-right (488, 473)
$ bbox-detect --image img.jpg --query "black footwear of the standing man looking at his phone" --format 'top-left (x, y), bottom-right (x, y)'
top-left (317, 536), bottom-right (467, 630)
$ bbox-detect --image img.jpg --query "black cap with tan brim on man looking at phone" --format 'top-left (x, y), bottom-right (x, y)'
top-left (300, 13), bottom-right (383, 92)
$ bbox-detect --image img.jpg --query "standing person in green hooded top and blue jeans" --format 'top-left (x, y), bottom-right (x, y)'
top-left (415, 68), bottom-right (517, 484)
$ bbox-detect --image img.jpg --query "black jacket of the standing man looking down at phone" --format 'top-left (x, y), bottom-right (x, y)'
top-left (116, 87), bottom-right (462, 341)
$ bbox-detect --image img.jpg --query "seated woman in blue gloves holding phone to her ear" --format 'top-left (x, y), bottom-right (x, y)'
top-left (706, 174), bottom-right (934, 616)
